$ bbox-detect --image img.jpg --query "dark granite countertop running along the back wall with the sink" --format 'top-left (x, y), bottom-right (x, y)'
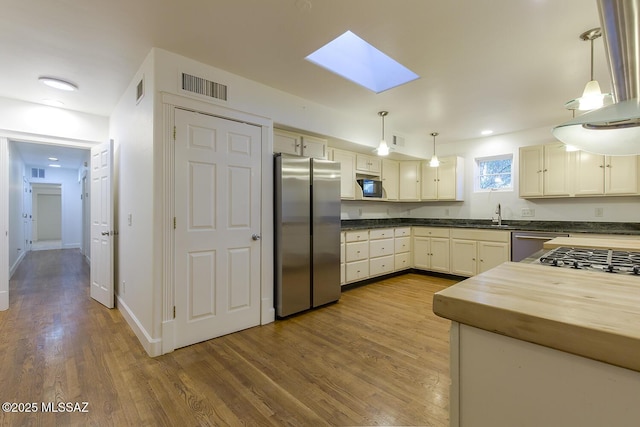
top-left (342, 218), bottom-right (640, 235)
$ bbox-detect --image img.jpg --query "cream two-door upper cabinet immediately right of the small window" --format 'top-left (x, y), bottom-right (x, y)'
top-left (520, 143), bottom-right (571, 197)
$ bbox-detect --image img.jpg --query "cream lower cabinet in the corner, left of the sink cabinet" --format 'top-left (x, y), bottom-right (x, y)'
top-left (413, 227), bottom-right (450, 273)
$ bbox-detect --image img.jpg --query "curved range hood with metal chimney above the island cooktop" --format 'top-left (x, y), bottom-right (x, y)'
top-left (552, 0), bottom-right (640, 156)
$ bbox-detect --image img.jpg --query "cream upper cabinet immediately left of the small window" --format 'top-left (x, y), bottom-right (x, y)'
top-left (420, 156), bottom-right (464, 200)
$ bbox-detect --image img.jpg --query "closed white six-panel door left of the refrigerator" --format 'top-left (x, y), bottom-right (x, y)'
top-left (174, 110), bottom-right (261, 348)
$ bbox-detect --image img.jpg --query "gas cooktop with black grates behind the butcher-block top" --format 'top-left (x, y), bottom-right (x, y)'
top-left (538, 246), bottom-right (640, 276)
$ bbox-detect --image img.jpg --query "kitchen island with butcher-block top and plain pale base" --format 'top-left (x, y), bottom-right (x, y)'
top-left (433, 262), bottom-right (640, 427)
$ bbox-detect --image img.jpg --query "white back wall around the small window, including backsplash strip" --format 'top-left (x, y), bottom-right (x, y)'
top-left (342, 127), bottom-right (640, 222)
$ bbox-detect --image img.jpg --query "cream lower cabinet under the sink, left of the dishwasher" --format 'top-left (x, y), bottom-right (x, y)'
top-left (451, 228), bottom-right (511, 277)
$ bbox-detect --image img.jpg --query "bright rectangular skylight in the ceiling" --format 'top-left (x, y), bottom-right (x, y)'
top-left (305, 31), bottom-right (420, 93)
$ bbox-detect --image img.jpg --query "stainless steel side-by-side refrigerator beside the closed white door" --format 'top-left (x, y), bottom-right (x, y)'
top-left (274, 155), bottom-right (341, 317)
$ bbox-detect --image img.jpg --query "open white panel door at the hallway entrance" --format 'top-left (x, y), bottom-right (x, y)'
top-left (90, 142), bottom-right (114, 308)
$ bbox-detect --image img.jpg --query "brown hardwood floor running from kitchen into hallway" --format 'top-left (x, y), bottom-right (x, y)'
top-left (0, 250), bottom-right (455, 426)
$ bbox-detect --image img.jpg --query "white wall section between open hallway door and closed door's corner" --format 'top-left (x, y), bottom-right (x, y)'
top-left (109, 51), bottom-right (156, 351)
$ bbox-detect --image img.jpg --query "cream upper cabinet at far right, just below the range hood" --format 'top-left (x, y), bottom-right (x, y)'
top-left (574, 151), bottom-right (639, 196)
